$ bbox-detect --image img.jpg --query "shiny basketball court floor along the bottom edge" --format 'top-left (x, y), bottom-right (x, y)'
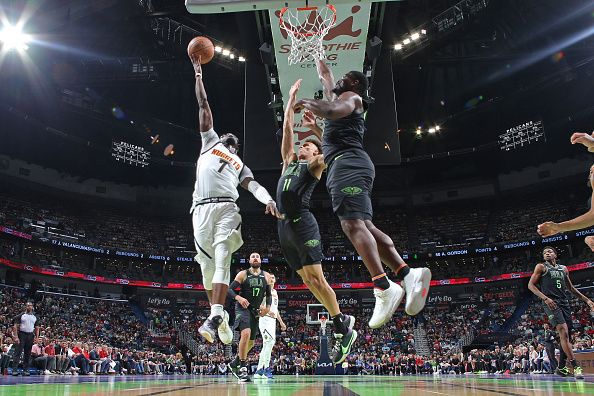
top-left (0, 375), bottom-right (594, 396)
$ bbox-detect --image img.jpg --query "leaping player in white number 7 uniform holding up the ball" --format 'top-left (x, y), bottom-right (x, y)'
top-left (190, 58), bottom-right (280, 344)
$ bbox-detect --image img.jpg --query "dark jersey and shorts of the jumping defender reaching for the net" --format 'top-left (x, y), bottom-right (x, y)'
top-left (322, 111), bottom-right (375, 220)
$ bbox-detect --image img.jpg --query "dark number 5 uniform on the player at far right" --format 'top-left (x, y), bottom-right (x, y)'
top-left (539, 262), bottom-right (572, 330)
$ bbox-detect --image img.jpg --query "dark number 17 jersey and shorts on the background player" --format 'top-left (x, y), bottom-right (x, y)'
top-left (229, 269), bottom-right (267, 340)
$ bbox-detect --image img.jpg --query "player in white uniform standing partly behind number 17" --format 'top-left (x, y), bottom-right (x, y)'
top-left (254, 274), bottom-right (287, 378)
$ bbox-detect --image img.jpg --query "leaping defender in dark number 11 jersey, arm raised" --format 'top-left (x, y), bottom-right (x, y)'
top-left (276, 80), bottom-right (357, 364)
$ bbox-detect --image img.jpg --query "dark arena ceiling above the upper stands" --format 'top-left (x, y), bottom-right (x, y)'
top-left (0, 0), bottom-right (594, 189)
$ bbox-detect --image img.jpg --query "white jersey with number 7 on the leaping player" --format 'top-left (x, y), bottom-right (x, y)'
top-left (192, 129), bottom-right (253, 208)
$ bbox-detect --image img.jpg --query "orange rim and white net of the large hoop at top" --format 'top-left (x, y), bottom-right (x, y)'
top-left (279, 4), bottom-right (336, 65)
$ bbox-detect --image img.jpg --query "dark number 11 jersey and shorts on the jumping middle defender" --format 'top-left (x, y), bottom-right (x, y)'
top-left (276, 161), bottom-right (324, 271)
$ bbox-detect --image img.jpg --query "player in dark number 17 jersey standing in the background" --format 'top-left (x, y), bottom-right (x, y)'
top-left (228, 253), bottom-right (272, 382)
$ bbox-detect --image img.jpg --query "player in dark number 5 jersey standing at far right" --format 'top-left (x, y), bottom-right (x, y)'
top-left (528, 246), bottom-right (594, 379)
